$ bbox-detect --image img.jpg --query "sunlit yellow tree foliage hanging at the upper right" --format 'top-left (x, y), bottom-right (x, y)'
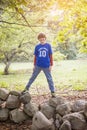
top-left (51, 0), bottom-right (87, 53)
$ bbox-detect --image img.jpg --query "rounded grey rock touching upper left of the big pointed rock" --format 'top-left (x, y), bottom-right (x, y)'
top-left (24, 103), bottom-right (38, 117)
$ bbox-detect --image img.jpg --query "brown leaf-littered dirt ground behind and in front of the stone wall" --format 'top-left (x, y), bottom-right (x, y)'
top-left (0, 90), bottom-right (87, 130)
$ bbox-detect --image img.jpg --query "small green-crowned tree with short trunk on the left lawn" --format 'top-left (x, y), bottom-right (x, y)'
top-left (0, 25), bottom-right (33, 74)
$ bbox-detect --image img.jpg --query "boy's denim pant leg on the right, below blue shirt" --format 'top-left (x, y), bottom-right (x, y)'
top-left (42, 68), bottom-right (55, 92)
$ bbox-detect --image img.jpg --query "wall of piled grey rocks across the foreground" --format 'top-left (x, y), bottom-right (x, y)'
top-left (0, 88), bottom-right (87, 130)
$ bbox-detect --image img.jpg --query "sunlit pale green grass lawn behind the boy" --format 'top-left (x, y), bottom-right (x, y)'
top-left (0, 60), bottom-right (87, 93)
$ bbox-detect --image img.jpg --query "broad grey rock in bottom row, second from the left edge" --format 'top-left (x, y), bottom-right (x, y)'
top-left (10, 109), bottom-right (28, 123)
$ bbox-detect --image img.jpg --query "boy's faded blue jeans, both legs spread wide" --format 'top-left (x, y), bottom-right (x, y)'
top-left (26, 66), bottom-right (55, 92)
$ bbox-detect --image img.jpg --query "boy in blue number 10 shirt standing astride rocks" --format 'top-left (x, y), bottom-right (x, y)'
top-left (22, 33), bottom-right (55, 97)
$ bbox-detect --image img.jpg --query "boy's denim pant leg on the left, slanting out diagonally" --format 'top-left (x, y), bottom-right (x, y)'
top-left (26, 66), bottom-right (41, 89)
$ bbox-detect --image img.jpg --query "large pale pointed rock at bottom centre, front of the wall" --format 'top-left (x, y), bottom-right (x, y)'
top-left (32, 111), bottom-right (53, 130)
